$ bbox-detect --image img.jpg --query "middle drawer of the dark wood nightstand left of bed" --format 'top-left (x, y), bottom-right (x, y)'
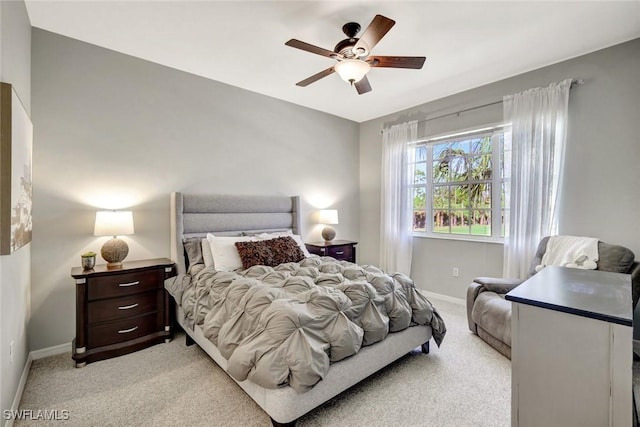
top-left (88, 291), bottom-right (164, 324)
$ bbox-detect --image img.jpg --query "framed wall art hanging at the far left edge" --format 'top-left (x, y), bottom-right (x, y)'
top-left (0, 83), bottom-right (33, 255)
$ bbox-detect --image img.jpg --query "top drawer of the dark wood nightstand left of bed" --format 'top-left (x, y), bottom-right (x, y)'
top-left (88, 269), bottom-right (164, 301)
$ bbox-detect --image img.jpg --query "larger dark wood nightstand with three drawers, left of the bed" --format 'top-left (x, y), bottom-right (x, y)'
top-left (71, 258), bottom-right (176, 368)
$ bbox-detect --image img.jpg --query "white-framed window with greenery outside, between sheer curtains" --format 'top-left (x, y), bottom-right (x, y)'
top-left (408, 127), bottom-right (506, 240)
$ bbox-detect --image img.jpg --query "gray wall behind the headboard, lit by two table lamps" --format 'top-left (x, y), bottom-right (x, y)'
top-left (29, 29), bottom-right (359, 349)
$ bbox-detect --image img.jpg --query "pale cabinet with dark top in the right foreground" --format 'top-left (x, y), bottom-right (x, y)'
top-left (506, 267), bottom-right (633, 427)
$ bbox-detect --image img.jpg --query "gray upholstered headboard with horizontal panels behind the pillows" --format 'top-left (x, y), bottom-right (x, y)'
top-left (171, 193), bottom-right (300, 273)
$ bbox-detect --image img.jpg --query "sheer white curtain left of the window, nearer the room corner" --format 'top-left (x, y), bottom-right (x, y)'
top-left (380, 121), bottom-right (418, 275)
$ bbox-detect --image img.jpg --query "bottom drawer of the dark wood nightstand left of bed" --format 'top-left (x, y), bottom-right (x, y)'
top-left (88, 313), bottom-right (163, 348)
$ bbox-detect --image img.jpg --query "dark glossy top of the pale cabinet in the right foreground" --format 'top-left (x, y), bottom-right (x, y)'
top-left (505, 266), bottom-right (633, 326)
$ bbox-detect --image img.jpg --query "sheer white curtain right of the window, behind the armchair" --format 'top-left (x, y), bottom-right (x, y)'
top-left (503, 79), bottom-right (571, 279)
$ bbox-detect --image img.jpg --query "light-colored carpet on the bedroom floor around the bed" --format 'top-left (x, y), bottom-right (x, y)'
top-left (15, 299), bottom-right (511, 427)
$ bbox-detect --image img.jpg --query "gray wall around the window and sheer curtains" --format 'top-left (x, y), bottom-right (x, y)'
top-left (360, 39), bottom-right (640, 298)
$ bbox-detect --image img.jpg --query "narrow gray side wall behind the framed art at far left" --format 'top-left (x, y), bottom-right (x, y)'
top-left (0, 1), bottom-right (31, 418)
